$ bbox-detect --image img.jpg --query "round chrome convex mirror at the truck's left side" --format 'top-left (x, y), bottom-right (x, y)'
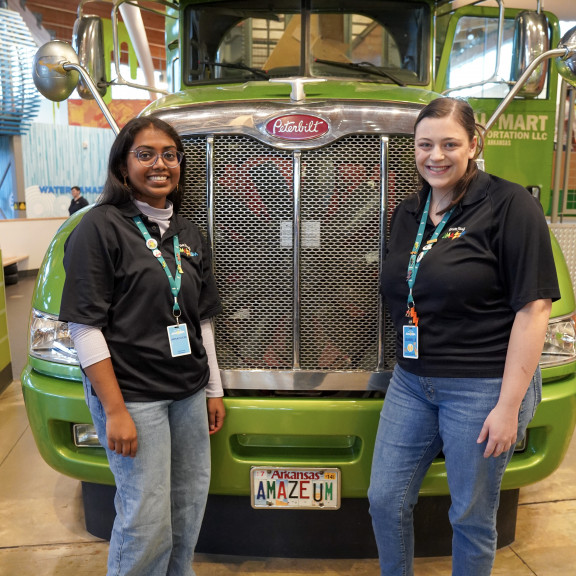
top-left (32, 40), bottom-right (79, 102)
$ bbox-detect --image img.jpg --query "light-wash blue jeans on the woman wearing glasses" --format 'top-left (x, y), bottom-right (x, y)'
top-left (85, 381), bottom-right (210, 576)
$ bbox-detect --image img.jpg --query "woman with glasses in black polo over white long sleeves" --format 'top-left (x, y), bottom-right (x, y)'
top-left (60, 117), bottom-right (225, 576)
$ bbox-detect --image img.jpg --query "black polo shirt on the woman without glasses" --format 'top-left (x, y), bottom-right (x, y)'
top-left (381, 172), bottom-right (560, 378)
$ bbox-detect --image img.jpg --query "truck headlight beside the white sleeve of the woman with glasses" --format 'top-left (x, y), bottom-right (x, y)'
top-left (29, 309), bottom-right (79, 366)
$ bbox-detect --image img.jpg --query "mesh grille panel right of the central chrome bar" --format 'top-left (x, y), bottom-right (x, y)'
top-left (300, 136), bottom-right (381, 370)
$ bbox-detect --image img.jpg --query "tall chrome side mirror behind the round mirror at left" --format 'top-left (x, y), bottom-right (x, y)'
top-left (72, 16), bottom-right (107, 100)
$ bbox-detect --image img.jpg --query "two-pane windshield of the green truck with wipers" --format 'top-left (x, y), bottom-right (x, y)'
top-left (183, 0), bottom-right (430, 85)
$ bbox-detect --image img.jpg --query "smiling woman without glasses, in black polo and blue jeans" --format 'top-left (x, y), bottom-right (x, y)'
top-left (368, 98), bottom-right (560, 576)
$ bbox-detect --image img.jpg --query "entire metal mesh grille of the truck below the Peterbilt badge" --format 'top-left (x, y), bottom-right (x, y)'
top-left (182, 135), bottom-right (414, 371)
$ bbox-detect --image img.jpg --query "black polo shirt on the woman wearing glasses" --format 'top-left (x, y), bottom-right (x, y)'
top-left (60, 202), bottom-right (221, 402)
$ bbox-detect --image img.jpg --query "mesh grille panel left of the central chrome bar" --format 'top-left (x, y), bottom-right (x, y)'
top-left (214, 136), bottom-right (293, 369)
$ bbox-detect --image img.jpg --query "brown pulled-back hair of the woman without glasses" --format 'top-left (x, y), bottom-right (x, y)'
top-left (414, 98), bottom-right (484, 214)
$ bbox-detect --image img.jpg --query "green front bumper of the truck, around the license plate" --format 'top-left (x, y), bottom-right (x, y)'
top-left (22, 368), bottom-right (576, 498)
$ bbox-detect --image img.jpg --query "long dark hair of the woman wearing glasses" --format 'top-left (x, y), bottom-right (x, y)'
top-left (98, 116), bottom-right (186, 212)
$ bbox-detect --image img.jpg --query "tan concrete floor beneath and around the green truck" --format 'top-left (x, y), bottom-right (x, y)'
top-left (0, 279), bottom-right (576, 576)
